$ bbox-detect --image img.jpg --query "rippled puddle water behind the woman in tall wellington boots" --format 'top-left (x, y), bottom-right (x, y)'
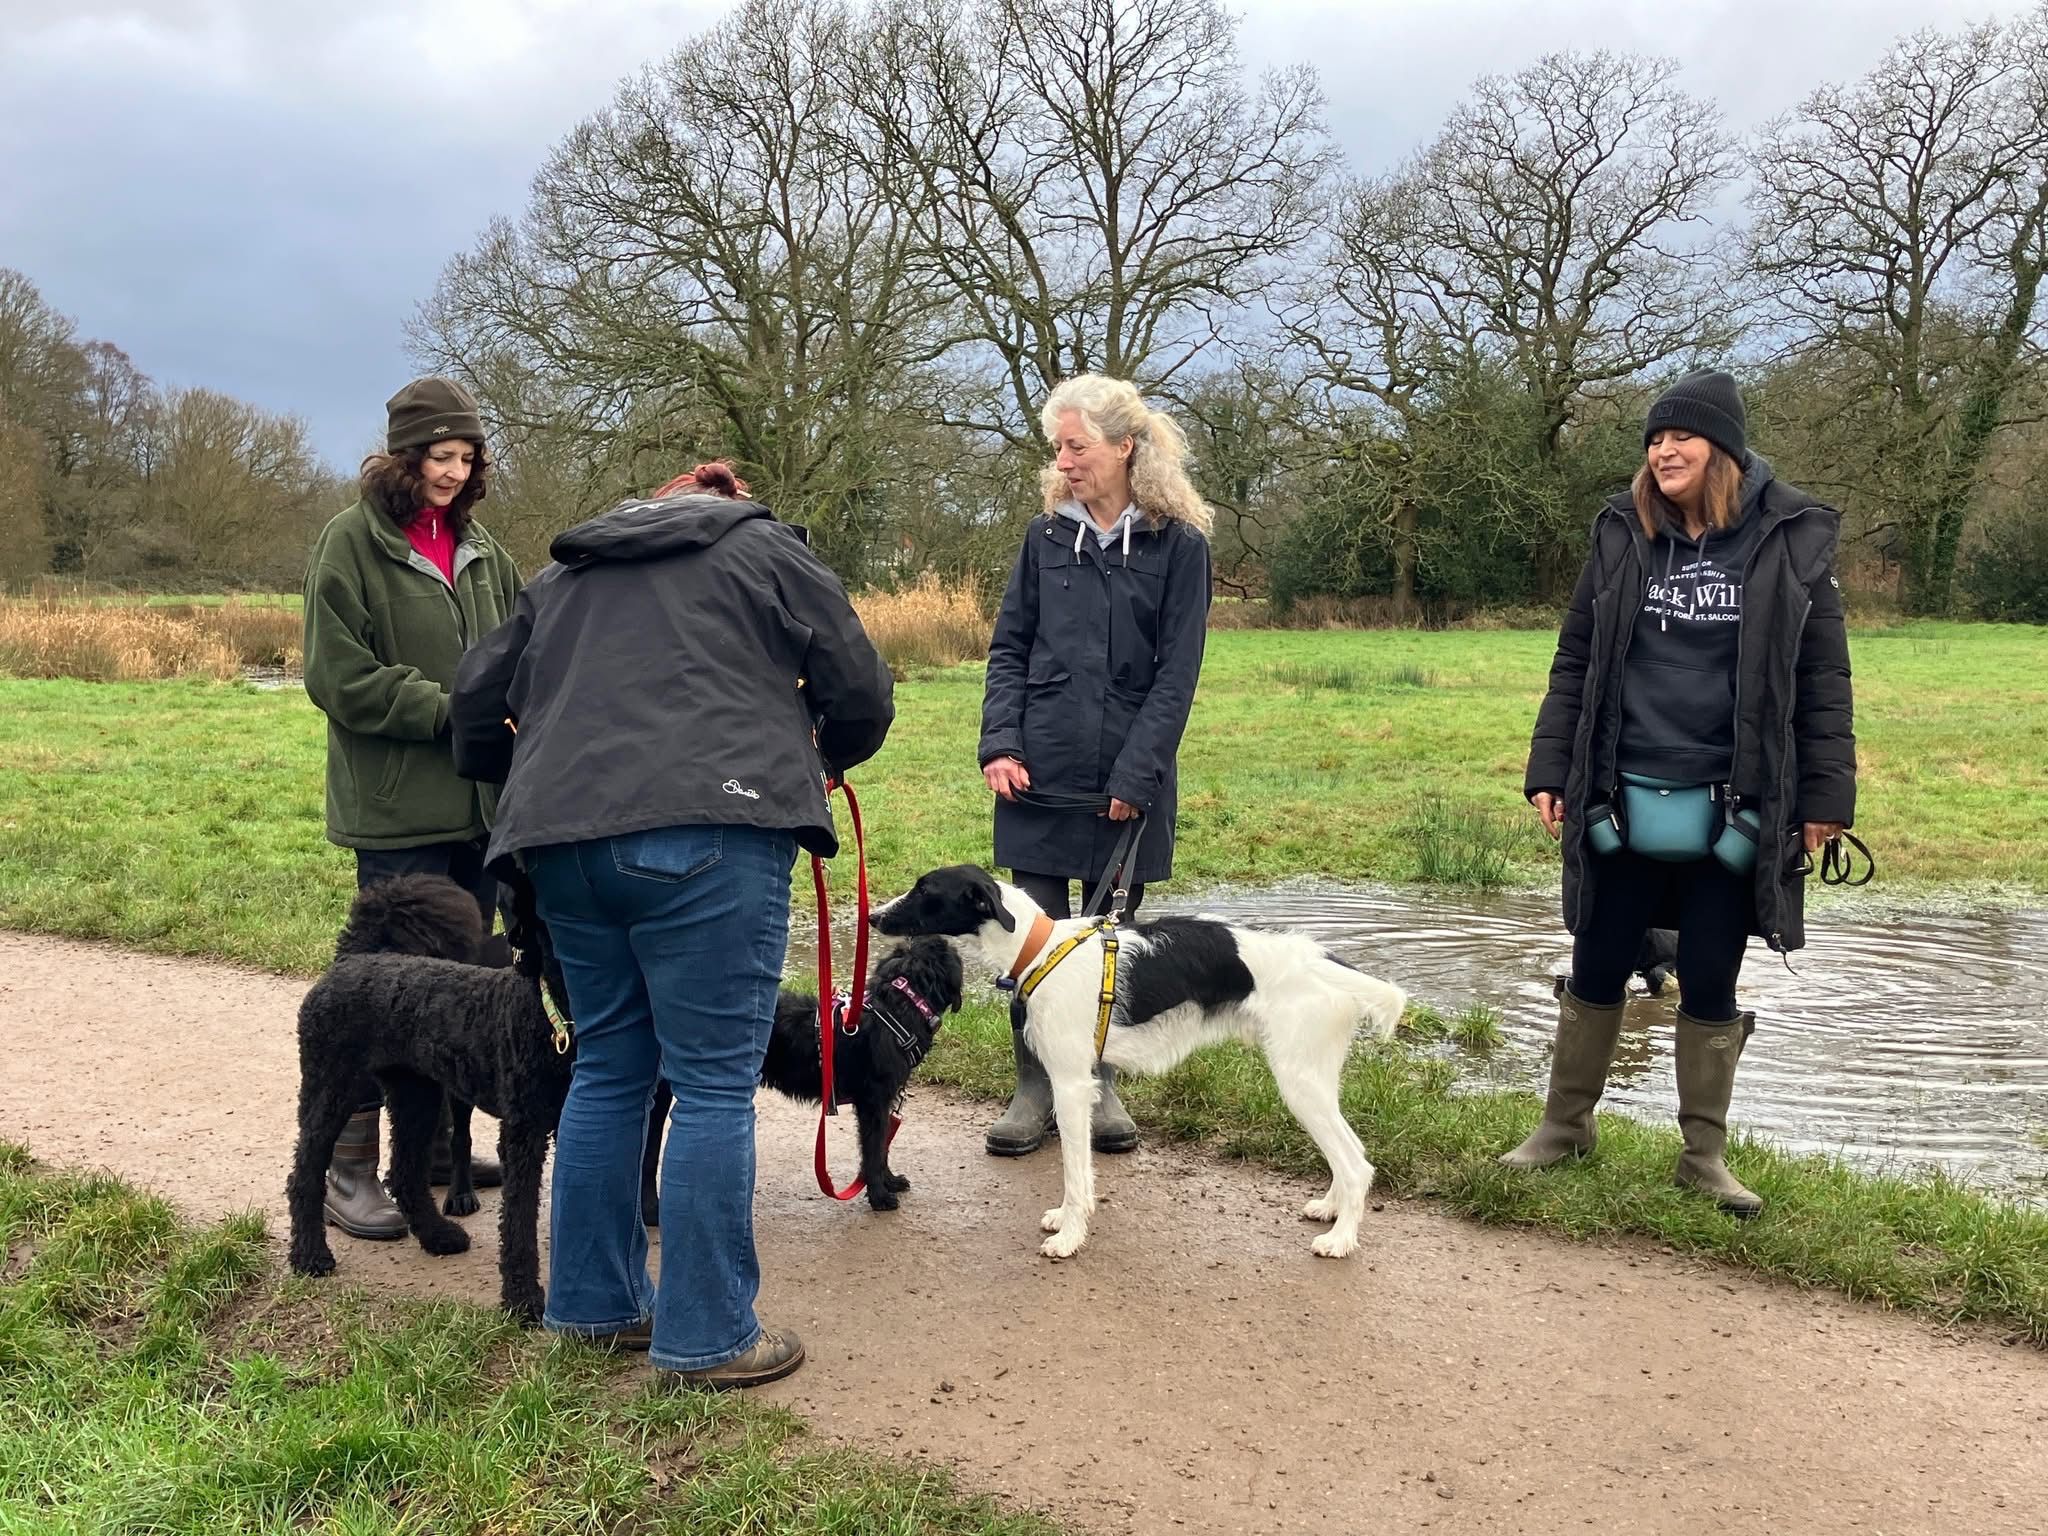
top-left (1145, 887), bottom-right (2048, 1198)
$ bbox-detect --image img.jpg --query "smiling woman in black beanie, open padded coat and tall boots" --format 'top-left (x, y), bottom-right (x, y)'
top-left (1501, 373), bottom-right (1855, 1217)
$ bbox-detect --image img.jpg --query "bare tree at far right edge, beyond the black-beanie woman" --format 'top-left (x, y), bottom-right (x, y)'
top-left (1751, 12), bottom-right (2048, 612)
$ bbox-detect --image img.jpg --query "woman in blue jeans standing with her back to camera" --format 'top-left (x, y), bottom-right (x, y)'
top-left (455, 465), bottom-right (895, 1386)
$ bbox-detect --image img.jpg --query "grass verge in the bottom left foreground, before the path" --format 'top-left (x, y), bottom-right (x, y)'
top-left (0, 1143), bottom-right (1053, 1536)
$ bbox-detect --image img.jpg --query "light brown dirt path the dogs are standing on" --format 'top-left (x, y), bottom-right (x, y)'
top-left (0, 934), bottom-right (2048, 1536)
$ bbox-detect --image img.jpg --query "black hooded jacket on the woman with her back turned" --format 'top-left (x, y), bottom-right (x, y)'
top-left (449, 496), bottom-right (895, 862)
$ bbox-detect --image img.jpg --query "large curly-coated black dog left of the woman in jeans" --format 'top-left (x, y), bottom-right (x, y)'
top-left (287, 874), bottom-right (575, 1323)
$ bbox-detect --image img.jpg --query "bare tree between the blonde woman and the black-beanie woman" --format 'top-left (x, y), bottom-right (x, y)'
top-left (1276, 53), bottom-right (1739, 610)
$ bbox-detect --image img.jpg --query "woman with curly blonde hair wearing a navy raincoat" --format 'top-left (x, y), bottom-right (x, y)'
top-left (979, 373), bottom-right (1210, 1157)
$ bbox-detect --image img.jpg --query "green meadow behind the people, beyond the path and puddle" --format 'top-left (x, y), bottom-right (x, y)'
top-left (0, 625), bottom-right (2048, 971)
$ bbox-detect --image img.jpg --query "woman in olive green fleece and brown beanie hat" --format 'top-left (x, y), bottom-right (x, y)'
top-left (305, 379), bottom-right (520, 1237)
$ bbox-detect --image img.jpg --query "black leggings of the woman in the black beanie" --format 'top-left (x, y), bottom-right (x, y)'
top-left (1564, 848), bottom-right (1751, 1024)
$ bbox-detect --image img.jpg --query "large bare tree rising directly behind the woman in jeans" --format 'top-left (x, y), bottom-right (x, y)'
top-left (416, 0), bottom-right (950, 573)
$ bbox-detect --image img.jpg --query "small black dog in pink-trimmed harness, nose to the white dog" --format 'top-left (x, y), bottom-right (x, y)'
top-left (641, 938), bottom-right (961, 1227)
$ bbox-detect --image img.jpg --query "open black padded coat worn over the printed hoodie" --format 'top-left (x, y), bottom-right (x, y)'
top-left (1524, 479), bottom-right (1855, 950)
